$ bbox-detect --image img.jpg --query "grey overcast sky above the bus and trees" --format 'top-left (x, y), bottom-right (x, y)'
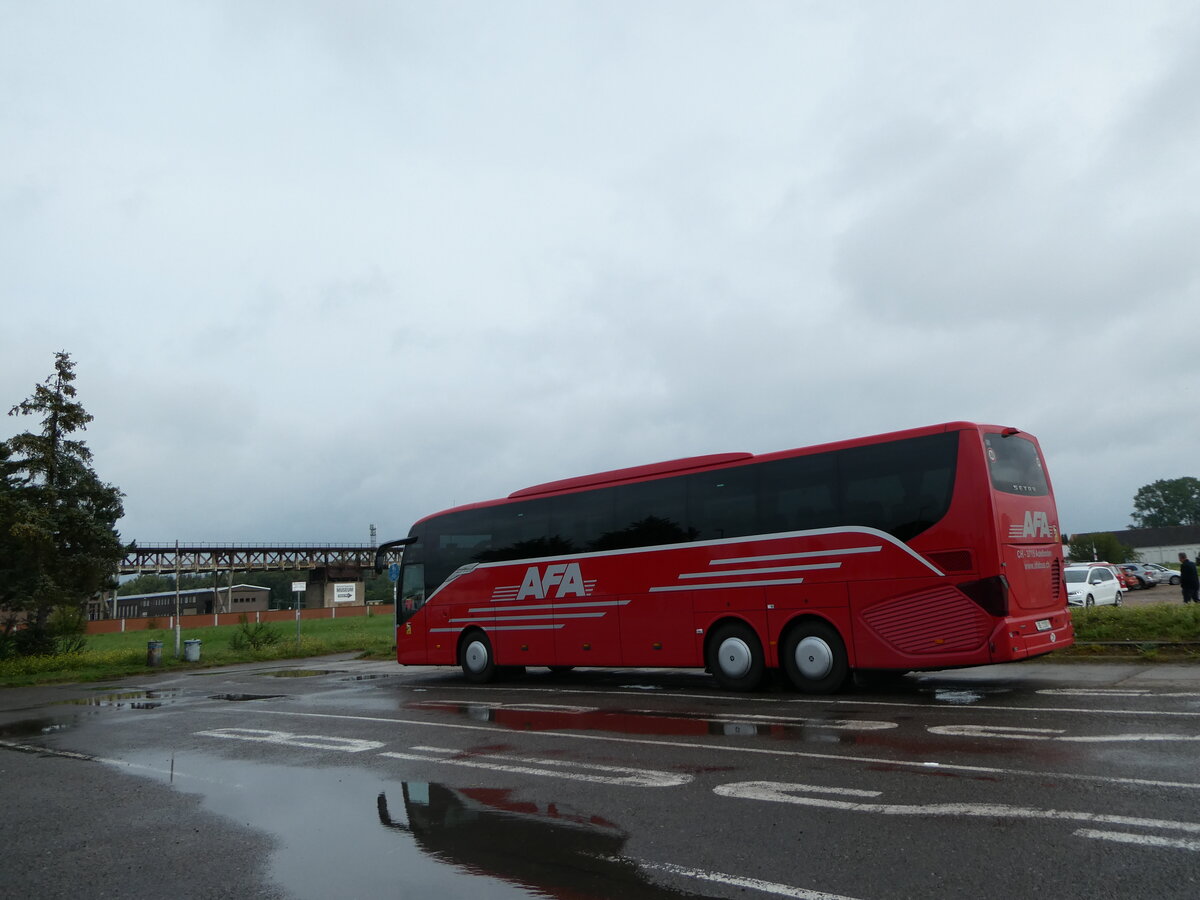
top-left (0, 0), bottom-right (1200, 542)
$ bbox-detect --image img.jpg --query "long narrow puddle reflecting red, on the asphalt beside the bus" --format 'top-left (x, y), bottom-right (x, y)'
top-left (404, 700), bottom-right (896, 743)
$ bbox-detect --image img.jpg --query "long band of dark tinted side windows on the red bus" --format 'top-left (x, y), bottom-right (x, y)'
top-left (417, 432), bottom-right (960, 592)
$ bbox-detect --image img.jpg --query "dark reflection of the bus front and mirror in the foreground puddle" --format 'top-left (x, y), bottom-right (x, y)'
top-left (377, 781), bottom-right (695, 900)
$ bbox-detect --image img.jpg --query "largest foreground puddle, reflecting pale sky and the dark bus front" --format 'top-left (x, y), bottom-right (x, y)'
top-left (108, 751), bottom-right (702, 900)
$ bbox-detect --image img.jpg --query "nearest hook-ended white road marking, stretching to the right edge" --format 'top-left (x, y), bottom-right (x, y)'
top-left (713, 781), bottom-right (1200, 834)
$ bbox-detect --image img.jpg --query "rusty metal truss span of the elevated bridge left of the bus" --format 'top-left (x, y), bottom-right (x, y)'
top-left (119, 544), bottom-right (400, 575)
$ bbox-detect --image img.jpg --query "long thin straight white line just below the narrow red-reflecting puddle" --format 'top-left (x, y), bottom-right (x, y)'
top-left (208, 706), bottom-right (1200, 791)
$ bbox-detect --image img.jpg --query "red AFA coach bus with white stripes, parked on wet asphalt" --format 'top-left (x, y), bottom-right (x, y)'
top-left (379, 422), bottom-right (1074, 692)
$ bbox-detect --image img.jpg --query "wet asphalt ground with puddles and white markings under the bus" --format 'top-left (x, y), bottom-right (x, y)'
top-left (0, 658), bottom-right (1200, 900)
